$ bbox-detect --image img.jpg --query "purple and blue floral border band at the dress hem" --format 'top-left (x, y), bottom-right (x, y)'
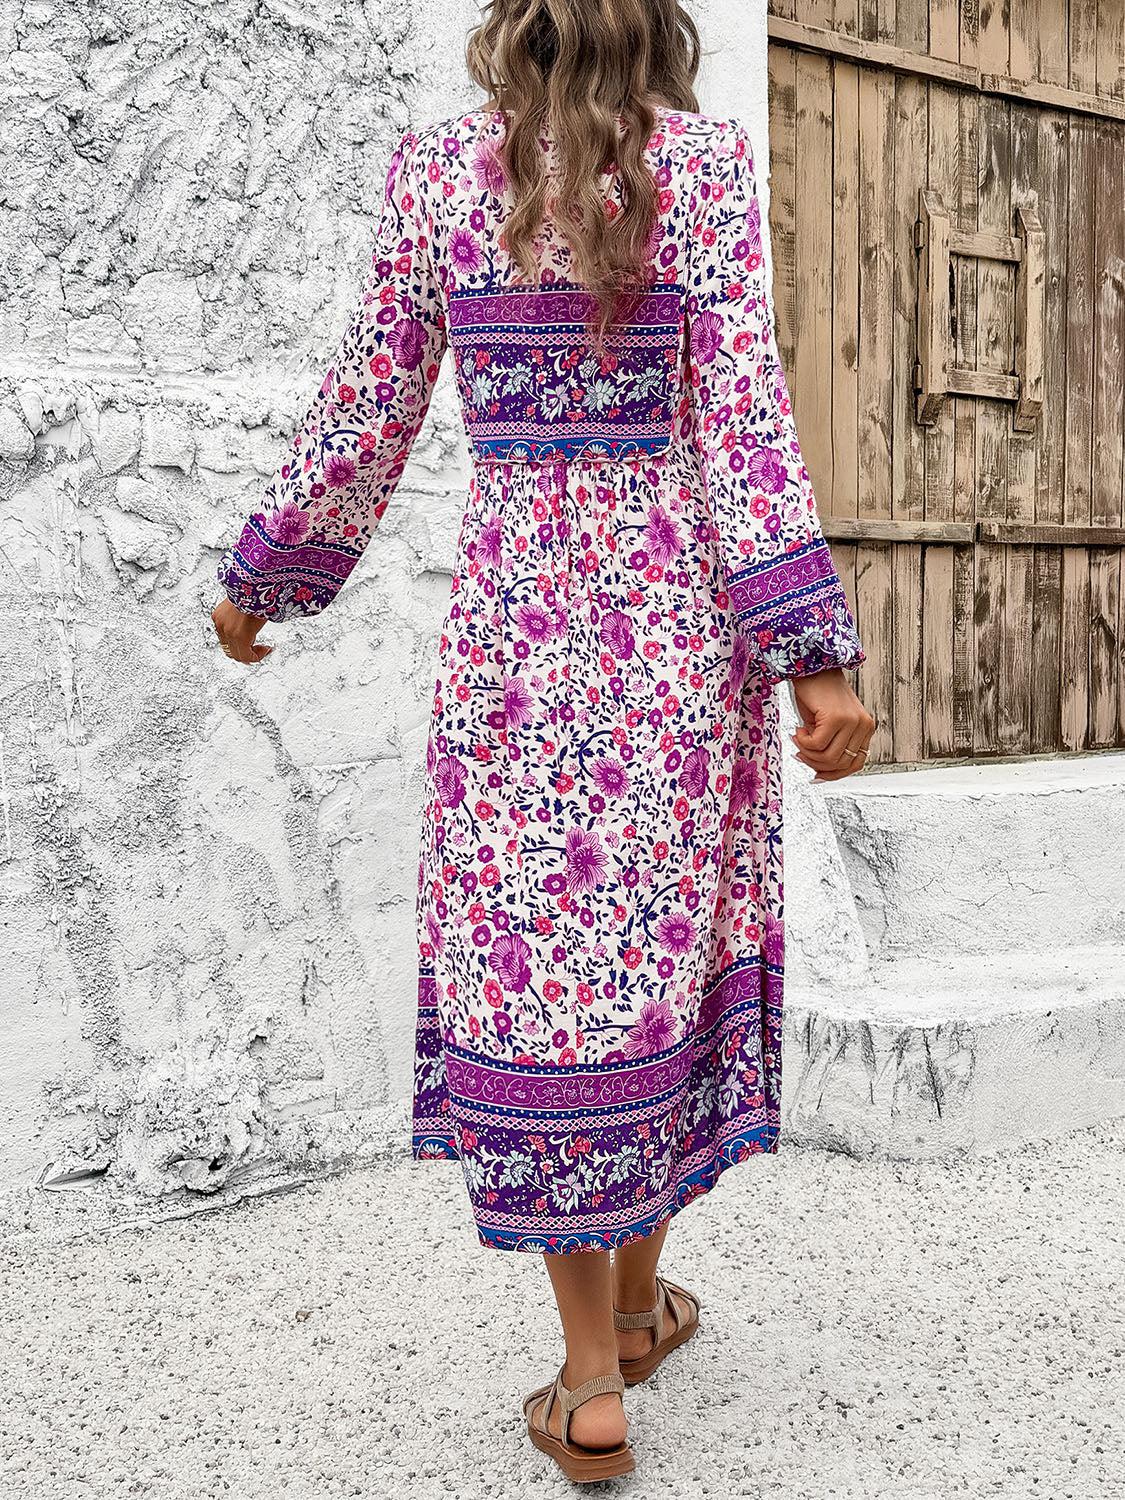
top-left (411, 960), bottom-right (783, 1254)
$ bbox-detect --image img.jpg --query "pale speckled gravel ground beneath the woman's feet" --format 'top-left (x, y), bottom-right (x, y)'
top-left (0, 1121), bottom-right (1125, 1500)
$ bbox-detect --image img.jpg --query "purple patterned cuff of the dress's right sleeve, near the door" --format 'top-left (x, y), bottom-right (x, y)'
top-left (729, 537), bottom-right (866, 683)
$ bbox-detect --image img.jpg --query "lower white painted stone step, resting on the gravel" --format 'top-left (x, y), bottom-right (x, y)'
top-left (783, 933), bottom-right (1125, 1158)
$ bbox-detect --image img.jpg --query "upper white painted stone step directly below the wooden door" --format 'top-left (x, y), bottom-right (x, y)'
top-left (825, 753), bottom-right (1125, 954)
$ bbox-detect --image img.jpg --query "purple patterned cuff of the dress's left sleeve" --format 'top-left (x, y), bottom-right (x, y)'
top-left (216, 515), bottom-right (363, 623)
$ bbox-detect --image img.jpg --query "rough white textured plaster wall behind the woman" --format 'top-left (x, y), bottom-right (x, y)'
top-left (0, 0), bottom-right (857, 1196)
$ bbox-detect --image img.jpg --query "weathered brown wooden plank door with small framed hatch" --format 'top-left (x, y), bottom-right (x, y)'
top-left (770, 0), bottom-right (1125, 764)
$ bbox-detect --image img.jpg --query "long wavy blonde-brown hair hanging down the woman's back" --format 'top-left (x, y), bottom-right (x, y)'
top-left (468, 0), bottom-right (699, 339)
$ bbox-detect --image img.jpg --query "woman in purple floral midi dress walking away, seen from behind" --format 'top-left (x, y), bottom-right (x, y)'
top-left (213, 0), bottom-right (875, 1481)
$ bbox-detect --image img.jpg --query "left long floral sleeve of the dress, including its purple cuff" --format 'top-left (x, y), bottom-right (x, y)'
top-left (218, 135), bottom-right (446, 620)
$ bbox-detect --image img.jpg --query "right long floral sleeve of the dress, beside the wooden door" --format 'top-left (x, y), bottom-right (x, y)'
top-left (687, 126), bottom-right (864, 681)
